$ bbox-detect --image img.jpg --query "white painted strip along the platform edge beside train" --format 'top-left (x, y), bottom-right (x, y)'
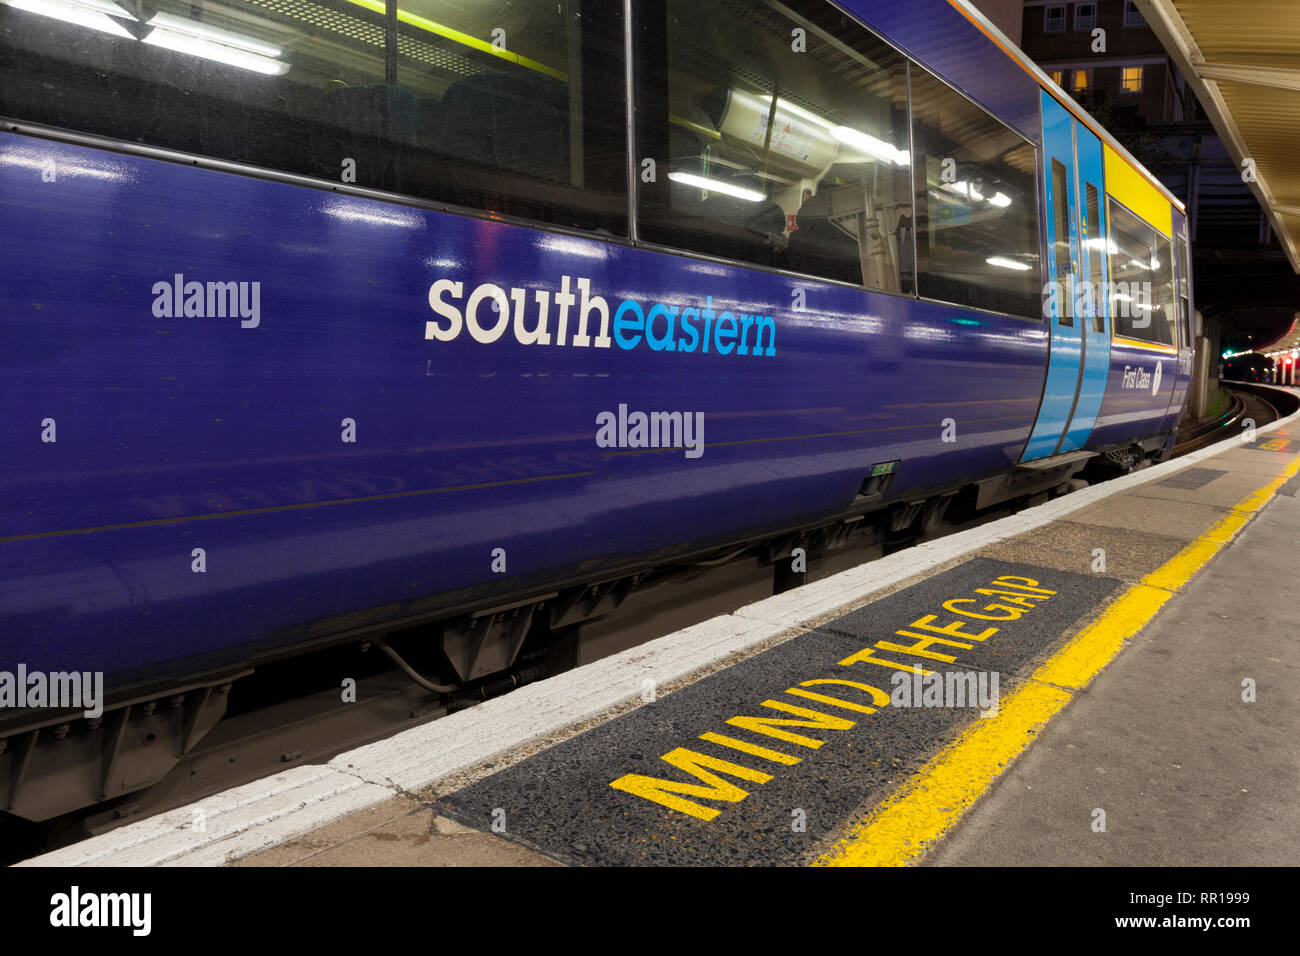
top-left (16, 395), bottom-right (1300, 866)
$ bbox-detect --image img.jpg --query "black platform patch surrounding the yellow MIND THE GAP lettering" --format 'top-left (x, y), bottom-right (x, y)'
top-left (439, 558), bottom-right (1118, 865)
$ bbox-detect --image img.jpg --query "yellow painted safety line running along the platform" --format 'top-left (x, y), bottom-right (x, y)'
top-left (814, 444), bottom-right (1300, 866)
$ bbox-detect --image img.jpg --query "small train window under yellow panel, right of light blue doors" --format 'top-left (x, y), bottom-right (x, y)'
top-left (1106, 199), bottom-right (1175, 345)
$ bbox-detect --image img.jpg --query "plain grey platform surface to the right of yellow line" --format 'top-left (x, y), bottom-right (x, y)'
top-left (932, 486), bottom-right (1300, 866)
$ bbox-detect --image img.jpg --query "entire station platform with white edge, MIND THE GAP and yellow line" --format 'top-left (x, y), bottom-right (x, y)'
top-left (26, 416), bottom-right (1300, 865)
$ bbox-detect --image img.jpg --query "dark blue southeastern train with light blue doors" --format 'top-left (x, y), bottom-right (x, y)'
top-left (0, 0), bottom-right (1192, 819)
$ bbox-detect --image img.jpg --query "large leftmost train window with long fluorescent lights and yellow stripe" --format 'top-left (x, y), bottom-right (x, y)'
top-left (0, 0), bottom-right (628, 234)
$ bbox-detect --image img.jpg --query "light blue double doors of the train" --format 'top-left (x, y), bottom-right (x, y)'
top-left (1021, 92), bottom-right (1110, 462)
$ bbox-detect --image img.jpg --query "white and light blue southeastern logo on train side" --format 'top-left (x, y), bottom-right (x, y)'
top-left (424, 276), bottom-right (776, 358)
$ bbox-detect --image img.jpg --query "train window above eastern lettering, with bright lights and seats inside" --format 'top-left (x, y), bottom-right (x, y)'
top-left (633, 0), bottom-right (914, 293)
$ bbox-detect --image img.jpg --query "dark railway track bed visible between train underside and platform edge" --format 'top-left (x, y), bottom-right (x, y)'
top-left (0, 389), bottom-right (1281, 864)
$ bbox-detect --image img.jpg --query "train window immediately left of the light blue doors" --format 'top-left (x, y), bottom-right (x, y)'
top-left (911, 68), bottom-right (1040, 319)
